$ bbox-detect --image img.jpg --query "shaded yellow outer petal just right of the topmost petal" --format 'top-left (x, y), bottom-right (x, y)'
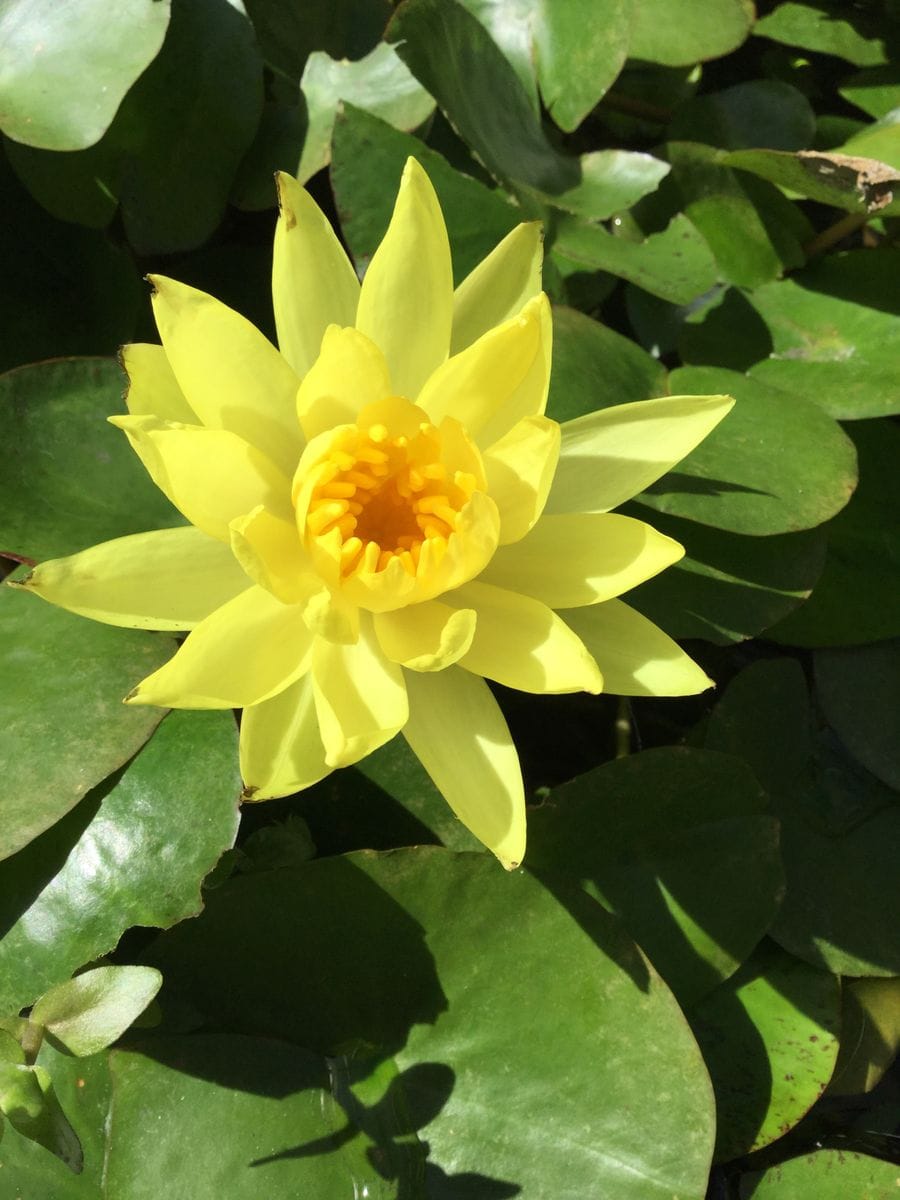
top-left (450, 221), bottom-right (544, 354)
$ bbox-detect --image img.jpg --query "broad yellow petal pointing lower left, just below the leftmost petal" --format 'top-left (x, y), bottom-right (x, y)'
top-left (127, 587), bottom-right (312, 708)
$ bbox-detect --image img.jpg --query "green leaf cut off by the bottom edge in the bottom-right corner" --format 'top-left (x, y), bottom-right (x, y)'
top-left (740, 1150), bottom-right (896, 1200)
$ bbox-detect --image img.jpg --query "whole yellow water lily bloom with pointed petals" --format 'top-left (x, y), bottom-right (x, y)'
top-left (14, 158), bottom-right (732, 868)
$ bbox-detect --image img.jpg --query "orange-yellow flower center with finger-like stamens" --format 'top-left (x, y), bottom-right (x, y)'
top-left (306, 415), bottom-right (478, 578)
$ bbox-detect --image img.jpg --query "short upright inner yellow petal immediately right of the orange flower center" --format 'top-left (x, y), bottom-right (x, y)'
top-left (484, 416), bottom-right (559, 546)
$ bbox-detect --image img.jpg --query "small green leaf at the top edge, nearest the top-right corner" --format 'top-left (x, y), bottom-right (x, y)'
top-left (754, 0), bottom-right (890, 67)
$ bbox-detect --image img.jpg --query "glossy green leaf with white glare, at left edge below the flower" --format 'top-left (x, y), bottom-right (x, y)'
top-left (0, 710), bottom-right (240, 1012)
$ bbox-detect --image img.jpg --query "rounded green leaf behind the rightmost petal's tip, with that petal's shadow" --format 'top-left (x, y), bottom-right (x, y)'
top-left (640, 367), bottom-right (857, 536)
